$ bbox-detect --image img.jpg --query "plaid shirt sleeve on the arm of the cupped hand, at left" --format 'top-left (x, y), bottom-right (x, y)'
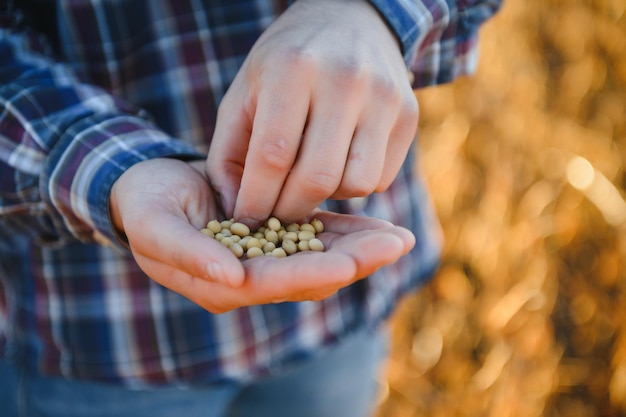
top-left (0, 23), bottom-right (202, 247)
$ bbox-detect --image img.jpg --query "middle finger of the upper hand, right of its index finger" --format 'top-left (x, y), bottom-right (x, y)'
top-left (274, 77), bottom-right (362, 221)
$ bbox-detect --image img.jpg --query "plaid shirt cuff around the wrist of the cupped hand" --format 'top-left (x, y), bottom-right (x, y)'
top-left (40, 114), bottom-right (205, 247)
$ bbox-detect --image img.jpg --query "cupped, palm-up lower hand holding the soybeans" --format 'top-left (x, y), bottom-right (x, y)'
top-left (110, 159), bottom-right (415, 313)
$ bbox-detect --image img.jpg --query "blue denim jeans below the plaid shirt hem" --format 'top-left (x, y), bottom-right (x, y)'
top-left (0, 324), bottom-right (387, 417)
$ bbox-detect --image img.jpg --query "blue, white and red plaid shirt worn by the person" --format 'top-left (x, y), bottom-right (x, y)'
top-left (0, 0), bottom-right (499, 386)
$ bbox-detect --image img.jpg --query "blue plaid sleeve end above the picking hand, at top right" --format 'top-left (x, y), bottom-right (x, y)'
top-left (369, 0), bottom-right (502, 88)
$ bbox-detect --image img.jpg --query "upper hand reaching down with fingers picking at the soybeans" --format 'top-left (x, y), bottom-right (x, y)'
top-left (207, 0), bottom-right (418, 225)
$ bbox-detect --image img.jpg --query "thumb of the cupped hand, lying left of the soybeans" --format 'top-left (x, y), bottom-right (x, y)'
top-left (129, 207), bottom-right (244, 287)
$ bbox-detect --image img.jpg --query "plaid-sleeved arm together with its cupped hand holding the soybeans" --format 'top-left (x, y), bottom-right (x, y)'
top-left (0, 8), bottom-right (414, 312)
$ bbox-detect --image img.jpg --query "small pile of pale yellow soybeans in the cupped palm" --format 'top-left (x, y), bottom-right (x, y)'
top-left (200, 217), bottom-right (324, 258)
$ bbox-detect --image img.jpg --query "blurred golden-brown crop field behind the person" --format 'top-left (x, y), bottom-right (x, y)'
top-left (378, 0), bottom-right (626, 417)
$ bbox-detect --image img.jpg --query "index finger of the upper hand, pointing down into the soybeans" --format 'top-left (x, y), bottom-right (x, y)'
top-left (234, 75), bottom-right (310, 225)
